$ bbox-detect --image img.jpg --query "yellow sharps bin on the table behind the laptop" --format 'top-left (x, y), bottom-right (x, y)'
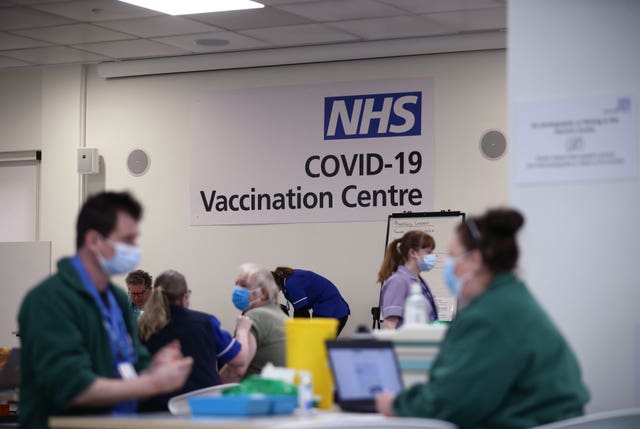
top-left (285, 318), bottom-right (338, 409)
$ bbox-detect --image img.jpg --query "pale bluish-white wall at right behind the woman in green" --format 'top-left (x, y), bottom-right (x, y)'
top-left (508, 0), bottom-right (640, 411)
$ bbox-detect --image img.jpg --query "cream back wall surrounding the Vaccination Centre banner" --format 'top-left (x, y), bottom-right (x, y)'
top-left (0, 51), bottom-right (508, 342)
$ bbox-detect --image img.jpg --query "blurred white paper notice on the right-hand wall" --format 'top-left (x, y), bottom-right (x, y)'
top-left (514, 96), bottom-right (638, 183)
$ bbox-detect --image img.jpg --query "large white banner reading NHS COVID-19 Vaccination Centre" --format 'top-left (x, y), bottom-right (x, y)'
top-left (190, 79), bottom-right (434, 225)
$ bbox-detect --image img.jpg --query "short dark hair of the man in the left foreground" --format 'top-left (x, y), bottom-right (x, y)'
top-left (76, 192), bottom-right (142, 250)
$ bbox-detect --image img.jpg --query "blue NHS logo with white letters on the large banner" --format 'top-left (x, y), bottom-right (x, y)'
top-left (324, 91), bottom-right (422, 140)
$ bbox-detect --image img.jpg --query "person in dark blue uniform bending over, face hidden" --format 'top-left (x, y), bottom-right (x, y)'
top-left (271, 267), bottom-right (351, 335)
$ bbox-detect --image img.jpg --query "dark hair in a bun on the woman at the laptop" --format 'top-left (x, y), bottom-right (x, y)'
top-left (456, 208), bottom-right (524, 274)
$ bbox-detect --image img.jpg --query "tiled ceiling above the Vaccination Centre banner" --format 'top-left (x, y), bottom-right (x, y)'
top-left (0, 0), bottom-right (506, 73)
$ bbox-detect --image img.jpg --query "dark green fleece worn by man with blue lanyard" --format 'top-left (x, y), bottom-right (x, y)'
top-left (18, 258), bottom-right (150, 429)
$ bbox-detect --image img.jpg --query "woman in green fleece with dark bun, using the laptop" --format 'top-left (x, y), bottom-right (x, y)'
top-left (376, 209), bottom-right (589, 429)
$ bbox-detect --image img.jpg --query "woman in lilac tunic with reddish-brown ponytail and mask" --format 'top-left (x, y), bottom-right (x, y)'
top-left (378, 230), bottom-right (438, 329)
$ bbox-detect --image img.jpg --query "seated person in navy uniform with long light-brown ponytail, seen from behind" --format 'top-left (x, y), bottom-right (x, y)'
top-left (138, 270), bottom-right (251, 411)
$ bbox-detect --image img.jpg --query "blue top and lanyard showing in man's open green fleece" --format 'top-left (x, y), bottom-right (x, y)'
top-left (71, 255), bottom-right (136, 374)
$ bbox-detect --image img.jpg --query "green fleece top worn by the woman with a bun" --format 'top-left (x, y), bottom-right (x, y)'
top-left (393, 272), bottom-right (589, 429)
